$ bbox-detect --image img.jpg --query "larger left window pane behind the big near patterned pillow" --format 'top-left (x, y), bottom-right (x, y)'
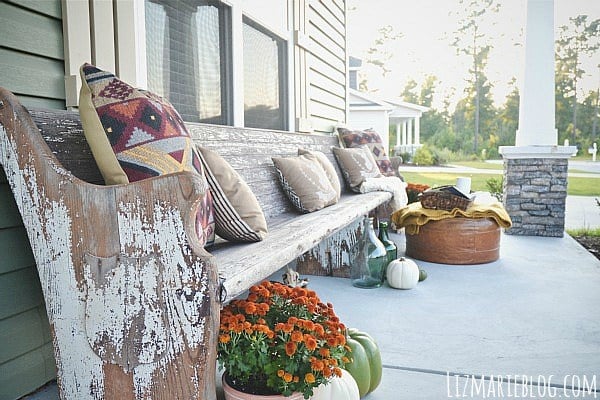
top-left (145, 0), bottom-right (232, 124)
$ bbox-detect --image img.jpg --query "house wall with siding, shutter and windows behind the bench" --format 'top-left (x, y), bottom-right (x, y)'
top-left (0, 0), bottom-right (348, 399)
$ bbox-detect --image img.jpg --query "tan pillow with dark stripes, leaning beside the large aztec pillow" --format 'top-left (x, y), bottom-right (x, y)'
top-left (196, 146), bottom-right (267, 242)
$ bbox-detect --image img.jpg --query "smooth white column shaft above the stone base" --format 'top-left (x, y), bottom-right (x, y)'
top-left (516, 0), bottom-right (558, 146)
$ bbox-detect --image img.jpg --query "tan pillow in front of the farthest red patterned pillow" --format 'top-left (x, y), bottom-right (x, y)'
top-left (333, 147), bottom-right (383, 192)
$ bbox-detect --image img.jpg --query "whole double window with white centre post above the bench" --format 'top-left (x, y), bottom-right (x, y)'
top-left (144, 0), bottom-right (290, 130)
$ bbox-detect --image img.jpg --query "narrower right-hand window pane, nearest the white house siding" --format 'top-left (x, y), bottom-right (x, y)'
top-left (243, 19), bottom-right (286, 130)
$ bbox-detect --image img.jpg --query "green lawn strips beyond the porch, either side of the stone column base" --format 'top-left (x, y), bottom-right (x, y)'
top-left (401, 171), bottom-right (600, 196)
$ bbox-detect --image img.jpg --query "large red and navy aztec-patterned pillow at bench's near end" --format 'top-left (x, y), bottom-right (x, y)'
top-left (79, 64), bottom-right (215, 246)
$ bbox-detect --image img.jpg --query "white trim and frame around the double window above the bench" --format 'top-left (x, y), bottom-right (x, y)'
top-left (116, 0), bottom-right (295, 131)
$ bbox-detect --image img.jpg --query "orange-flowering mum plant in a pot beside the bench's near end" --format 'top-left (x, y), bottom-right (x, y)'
top-left (218, 282), bottom-right (350, 399)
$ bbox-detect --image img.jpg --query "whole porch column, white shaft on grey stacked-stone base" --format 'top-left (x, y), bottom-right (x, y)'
top-left (500, 0), bottom-right (577, 237)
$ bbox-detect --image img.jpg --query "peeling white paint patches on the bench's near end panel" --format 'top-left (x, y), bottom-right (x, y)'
top-left (0, 119), bottom-right (214, 400)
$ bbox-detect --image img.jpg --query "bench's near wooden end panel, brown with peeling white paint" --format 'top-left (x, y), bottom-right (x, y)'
top-left (0, 89), bottom-right (218, 400)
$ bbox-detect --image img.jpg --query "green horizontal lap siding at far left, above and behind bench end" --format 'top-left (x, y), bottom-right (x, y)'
top-left (0, 0), bottom-right (65, 400)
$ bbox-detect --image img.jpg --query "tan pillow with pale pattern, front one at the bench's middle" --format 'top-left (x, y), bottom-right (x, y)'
top-left (272, 154), bottom-right (337, 213)
